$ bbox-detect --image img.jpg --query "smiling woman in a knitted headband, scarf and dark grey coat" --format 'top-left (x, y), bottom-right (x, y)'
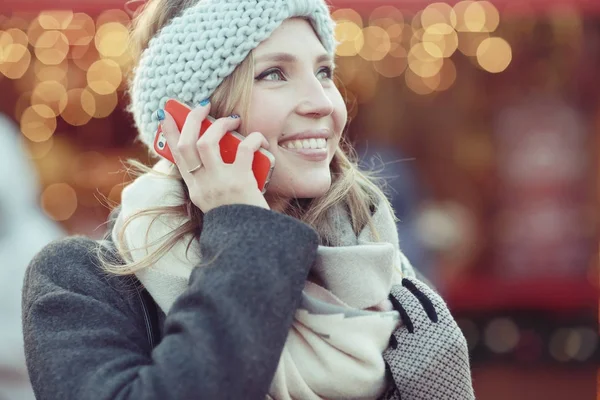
top-left (23, 0), bottom-right (474, 400)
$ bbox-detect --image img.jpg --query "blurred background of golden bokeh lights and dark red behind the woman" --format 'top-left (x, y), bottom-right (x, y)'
top-left (0, 0), bottom-right (600, 400)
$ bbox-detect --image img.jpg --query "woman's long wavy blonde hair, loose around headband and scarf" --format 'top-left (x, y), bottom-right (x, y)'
top-left (99, 0), bottom-right (393, 275)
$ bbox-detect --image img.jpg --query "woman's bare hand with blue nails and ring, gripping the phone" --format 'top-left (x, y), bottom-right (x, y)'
top-left (162, 104), bottom-right (269, 213)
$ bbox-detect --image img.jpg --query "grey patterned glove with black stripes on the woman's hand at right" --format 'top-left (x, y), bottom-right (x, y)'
top-left (383, 278), bottom-right (475, 400)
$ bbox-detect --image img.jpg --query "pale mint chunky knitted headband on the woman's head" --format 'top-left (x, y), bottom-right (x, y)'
top-left (130, 0), bottom-right (336, 149)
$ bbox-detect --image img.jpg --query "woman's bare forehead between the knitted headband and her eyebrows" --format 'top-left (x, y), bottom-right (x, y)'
top-left (254, 18), bottom-right (325, 57)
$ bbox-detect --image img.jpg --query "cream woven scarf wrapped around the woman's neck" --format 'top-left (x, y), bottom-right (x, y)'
top-left (112, 161), bottom-right (414, 400)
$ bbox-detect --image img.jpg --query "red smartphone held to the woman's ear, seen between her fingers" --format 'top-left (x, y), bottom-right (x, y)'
top-left (154, 99), bottom-right (275, 193)
